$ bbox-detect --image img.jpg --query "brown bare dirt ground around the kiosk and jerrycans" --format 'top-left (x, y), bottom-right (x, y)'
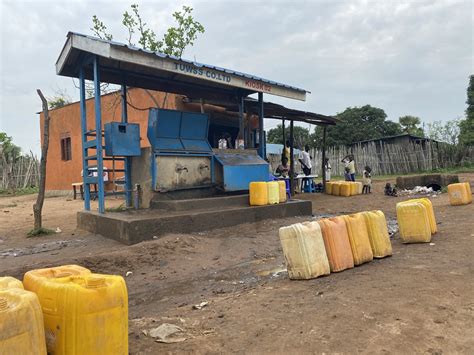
top-left (0, 174), bottom-right (474, 354)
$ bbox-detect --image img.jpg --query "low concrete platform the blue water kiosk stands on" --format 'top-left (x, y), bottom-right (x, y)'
top-left (77, 195), bottom-right (312, 245)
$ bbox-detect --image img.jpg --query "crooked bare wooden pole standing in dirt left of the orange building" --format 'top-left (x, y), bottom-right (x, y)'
top-left (33, 89), bottom-right (49, 229)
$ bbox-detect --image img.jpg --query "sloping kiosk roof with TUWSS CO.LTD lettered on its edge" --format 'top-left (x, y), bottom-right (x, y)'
top-left (56, 32), bottom-right (308, 101)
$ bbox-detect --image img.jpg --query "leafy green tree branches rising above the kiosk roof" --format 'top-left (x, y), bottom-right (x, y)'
top-left (91, 4), bottom-right (205, 58)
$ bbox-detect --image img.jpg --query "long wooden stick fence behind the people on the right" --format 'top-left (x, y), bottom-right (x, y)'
top-left (268, 141), bottom-right (474, 176)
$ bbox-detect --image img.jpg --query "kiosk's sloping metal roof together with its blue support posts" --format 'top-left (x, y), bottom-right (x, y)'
top-left (56, 32), bottom-right (324, 213)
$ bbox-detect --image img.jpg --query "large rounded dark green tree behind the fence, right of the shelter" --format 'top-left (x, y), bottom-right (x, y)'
top-left (312, 105), bottom-right (402, 147)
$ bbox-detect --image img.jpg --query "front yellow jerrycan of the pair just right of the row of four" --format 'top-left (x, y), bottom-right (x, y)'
top-left (397, 202), bottom-right (431, 243)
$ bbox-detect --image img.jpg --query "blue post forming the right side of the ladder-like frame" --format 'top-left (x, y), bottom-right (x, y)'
top-left (94, 56), bottom-right (105, 213)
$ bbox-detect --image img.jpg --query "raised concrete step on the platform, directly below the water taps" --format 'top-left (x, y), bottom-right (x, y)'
top-left (150, 195), bottom-right (249, 211)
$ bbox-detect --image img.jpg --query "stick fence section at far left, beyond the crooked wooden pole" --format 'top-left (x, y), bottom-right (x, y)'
top-left (0, 153), bottom-right (39, 190)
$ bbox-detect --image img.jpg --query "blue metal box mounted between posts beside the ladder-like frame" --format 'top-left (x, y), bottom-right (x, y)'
top-left (104, 122), bottom-right (141, 157)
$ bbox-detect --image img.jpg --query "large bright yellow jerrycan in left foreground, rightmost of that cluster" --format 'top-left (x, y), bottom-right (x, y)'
top-left (23, 269), bottom-right (128, 355)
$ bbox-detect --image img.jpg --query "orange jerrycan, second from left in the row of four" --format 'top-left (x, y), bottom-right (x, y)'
top-left (318, 217), bottom-right (354, 272)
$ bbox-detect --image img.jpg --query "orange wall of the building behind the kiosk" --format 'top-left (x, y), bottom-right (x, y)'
top-left (40, 89), bottom-right (183, 191)
